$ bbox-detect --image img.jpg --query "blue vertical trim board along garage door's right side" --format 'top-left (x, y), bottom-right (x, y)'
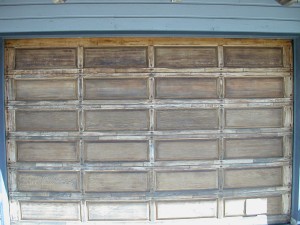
top-left (292, 37), bottom-right (300, 225)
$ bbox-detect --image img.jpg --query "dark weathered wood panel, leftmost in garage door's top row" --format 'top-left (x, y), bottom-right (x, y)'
top-left (15, 48), bottom-right (77, 70)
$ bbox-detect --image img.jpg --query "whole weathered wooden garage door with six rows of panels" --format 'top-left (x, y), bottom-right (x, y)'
top-left (5, 38), bottom-right (293, 225)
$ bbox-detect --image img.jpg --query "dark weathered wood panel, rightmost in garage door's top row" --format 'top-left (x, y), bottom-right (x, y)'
top-left (224, 46), bottom-right (283, 68)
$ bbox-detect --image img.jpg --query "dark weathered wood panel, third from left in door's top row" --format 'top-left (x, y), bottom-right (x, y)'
top-left (155, 46), bottom-right (218, 68)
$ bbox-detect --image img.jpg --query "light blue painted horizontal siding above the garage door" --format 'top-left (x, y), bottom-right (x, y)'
top-left (0, 0), bottom-right (300, 36)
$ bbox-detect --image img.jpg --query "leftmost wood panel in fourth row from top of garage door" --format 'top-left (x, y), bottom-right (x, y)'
top-left (16, 141), bottom-right (79, 162)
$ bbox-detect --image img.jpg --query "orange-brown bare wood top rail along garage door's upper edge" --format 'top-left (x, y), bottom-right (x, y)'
top-left (5, 37), bottom-right (291, 48)
